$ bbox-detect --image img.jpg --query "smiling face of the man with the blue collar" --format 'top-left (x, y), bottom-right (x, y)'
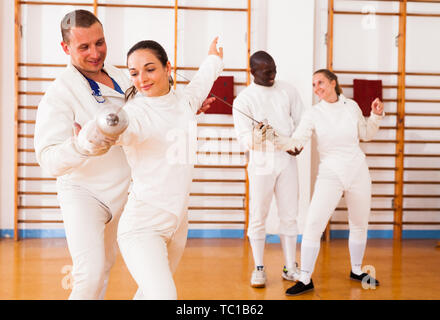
top-left (61, 22), bottom-right (107, 74)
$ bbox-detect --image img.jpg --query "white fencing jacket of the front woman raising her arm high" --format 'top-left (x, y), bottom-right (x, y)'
top-left (118, 55), bottom-right (223, 218)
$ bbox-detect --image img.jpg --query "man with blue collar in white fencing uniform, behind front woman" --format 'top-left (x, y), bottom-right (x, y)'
top-left (34, 10), bottom-right (130, 299)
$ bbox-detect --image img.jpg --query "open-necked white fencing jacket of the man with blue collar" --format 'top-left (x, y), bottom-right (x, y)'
top-left (34, 64), bottom-right (130, 212)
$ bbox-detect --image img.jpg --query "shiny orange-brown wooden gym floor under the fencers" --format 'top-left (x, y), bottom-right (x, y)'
top-left (0, 239), bottom-right (440, 300)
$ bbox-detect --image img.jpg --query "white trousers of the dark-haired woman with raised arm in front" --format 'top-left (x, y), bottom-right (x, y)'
top-left (118, 196), bottom-right (188, 300)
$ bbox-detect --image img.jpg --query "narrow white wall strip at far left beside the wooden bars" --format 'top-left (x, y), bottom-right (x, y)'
top-left (0, 0), bottom-right (15, 230)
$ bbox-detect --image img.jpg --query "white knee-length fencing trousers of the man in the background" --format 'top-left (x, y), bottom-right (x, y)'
top-left (247, 153), bottom-right (298, 239)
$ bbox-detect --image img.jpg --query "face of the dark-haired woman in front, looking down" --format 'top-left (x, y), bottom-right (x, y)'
top-left (127, 49), bottom-right (171, 97)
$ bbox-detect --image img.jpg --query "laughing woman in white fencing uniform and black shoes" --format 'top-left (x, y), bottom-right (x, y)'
top-left (275, 69), bottom-right (384, 295)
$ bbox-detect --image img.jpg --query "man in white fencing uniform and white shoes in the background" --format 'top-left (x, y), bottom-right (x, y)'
top-left (233, 51), bottom-right (303, 288)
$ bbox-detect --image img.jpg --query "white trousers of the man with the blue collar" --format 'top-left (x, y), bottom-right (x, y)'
top-left (58, 186), bottom-right (127, 300)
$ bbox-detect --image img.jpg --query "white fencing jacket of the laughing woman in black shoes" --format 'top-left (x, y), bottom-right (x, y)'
top-left (292, 94), bottom-right (384, 187)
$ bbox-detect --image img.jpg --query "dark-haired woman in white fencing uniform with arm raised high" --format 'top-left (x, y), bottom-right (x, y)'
top-left (110, 39), bottom-right (223, 299)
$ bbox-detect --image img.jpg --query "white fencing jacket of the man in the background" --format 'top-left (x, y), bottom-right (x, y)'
top-left (233, 80), bottom-right (304, 169)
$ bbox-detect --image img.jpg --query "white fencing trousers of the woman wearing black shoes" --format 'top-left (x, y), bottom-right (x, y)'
top-left (303, 161), bottom-right (371, 243)
